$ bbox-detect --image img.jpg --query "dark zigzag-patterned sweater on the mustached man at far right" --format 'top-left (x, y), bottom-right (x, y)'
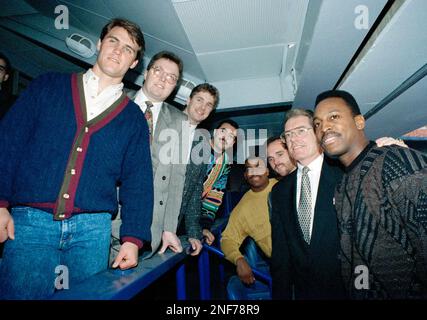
top-left (335, 142), bottom-right (427, 299)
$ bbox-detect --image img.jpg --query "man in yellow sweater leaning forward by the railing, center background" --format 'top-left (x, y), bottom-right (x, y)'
top-left (221, 157), bottom-right (277, 285)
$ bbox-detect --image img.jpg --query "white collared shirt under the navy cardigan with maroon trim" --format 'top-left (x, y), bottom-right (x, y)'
top-left (83, 69), bottom-right (123, 121)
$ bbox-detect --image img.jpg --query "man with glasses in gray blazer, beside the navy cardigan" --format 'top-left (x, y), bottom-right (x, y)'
top-left (124, 51), bottom-right (187, 254)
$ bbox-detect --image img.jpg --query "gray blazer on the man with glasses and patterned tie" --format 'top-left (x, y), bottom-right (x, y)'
top-left (128, 92), bottom-right (187, 254)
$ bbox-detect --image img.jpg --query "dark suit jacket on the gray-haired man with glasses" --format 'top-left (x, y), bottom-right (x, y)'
top-left (271, 156), bottom-right (344, 300)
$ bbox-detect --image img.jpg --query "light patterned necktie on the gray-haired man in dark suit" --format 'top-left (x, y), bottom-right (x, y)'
top-left (298, 167), bottom-right (311, 244)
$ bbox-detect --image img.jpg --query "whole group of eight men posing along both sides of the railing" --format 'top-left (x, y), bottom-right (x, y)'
top-left (0, 15), bottom-right (427, 299)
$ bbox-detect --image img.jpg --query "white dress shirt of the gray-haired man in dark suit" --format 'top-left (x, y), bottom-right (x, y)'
top-left (296, 153), bottom-right (324, 238)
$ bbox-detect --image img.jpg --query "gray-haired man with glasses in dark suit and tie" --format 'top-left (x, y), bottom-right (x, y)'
top-left (271, 109), bottom-right (344, 300)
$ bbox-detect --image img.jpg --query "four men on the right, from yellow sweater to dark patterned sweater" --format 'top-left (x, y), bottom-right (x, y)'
top-left (231, 90), bottom-right (427, 300)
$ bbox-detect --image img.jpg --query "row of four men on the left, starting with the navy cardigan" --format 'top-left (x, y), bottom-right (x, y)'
top-left (0, 19), bottom-right (237, 299)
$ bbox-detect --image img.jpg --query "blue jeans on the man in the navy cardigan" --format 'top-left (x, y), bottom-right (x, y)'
top-left (0, 207), bottom-right (111, 299)
